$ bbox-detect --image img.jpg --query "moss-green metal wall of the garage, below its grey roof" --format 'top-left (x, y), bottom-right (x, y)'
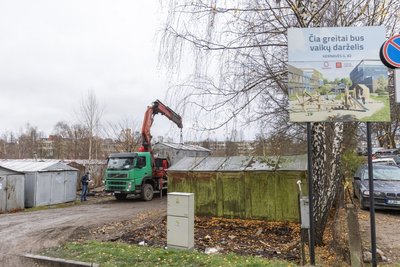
top-left (168, 170), bottom-right (307, 221)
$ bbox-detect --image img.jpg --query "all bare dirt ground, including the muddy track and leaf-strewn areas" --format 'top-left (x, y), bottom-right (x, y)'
top-left (0, 196), bottom-right (400, 266)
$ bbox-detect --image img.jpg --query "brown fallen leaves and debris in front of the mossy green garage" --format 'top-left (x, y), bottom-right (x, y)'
top-left (119, 217), bottom-right (300, 261)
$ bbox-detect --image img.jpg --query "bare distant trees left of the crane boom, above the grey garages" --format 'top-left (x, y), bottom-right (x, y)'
top-left (0, 122), bottom-right (140, 159)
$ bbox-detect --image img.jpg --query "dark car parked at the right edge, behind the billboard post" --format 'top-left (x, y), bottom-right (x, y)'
top-left (353, 164), bottom-right (400, 209)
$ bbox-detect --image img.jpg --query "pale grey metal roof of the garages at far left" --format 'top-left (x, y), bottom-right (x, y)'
top-left (0, 160), bottom-right (76, 172)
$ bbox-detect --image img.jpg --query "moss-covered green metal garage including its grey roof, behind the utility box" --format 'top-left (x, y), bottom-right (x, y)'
top-left (168, 155), bottom-right (307, 221)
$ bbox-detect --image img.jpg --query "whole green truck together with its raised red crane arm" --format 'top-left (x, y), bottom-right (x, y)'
top-left (104, 100), bottom-right (183, 201)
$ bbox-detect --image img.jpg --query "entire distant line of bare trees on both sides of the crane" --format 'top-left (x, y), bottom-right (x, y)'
top-left (0, 121), bottom-right (306, 159)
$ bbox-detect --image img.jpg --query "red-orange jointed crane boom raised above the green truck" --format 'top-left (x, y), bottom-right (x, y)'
top-left (140, 100), bottom-right (183, 153)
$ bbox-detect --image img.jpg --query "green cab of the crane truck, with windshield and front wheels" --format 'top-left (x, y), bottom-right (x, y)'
top-left (104, 152), bottom-right (166, 200)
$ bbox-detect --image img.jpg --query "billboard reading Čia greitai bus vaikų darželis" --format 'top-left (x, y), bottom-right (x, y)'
top-left (288, 26), bottom-right (390, 122)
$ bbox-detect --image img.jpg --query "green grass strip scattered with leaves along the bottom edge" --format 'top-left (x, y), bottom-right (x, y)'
top-left (42, 241), bottom-right (296, 267)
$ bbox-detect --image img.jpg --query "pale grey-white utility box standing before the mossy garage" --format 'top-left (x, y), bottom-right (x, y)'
top-left (167, 192), bottom-right (194, 249)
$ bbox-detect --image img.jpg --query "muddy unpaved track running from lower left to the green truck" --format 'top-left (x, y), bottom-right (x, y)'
top-left (0, 197), bottom-right (167, 266)
